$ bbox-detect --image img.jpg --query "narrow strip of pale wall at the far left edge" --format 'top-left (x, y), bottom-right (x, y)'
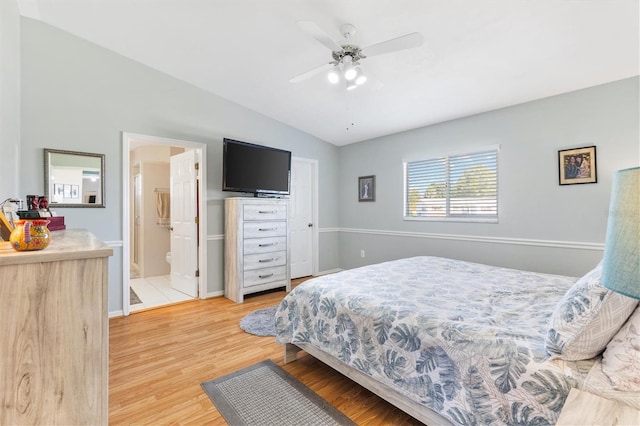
top-left (0, 0), bottom-right (20, 196)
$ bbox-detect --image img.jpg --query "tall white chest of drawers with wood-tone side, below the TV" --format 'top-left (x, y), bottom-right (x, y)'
top-left (224, 197), bottom-right (291, 303)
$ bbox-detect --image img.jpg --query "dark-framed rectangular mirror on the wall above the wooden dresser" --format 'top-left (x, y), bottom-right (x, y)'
top-left (44, 148), bottom-right (104, 208)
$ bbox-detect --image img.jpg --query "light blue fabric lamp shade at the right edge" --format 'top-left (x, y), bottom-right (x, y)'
top-left (602, 167), bottom-right (640, 299)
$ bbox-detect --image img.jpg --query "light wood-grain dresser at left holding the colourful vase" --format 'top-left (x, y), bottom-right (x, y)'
top-left (0, 230), bottom-right (113, 425)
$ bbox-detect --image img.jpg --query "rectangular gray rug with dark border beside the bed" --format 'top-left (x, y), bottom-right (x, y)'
top-left (201, 360), bottom-right (355, 426)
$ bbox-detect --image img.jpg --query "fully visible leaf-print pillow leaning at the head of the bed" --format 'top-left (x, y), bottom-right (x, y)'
top-left (545, 263), bottom-right (638, 361)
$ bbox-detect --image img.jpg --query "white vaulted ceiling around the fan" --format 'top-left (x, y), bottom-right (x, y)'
top-left (18, 0), bottom-right (639, 145)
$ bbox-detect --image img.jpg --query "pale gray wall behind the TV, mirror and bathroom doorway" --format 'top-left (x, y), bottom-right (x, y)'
top-left (20, 18), bottom-right (338, 312)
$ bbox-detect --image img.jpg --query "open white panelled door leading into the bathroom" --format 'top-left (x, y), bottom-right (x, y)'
top-left (170, 150), bottom-right (198, 297)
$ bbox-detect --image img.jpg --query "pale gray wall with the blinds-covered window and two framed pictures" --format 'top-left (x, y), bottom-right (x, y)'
top-left (339, 77), bottom-right (640, 276)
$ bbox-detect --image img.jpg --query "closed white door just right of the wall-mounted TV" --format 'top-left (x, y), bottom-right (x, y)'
top-left (289, 158), bottom-right (316, 278)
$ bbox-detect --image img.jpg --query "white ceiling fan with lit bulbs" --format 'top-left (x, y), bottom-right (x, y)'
top-left (289, 21), bottom-right (424, 90)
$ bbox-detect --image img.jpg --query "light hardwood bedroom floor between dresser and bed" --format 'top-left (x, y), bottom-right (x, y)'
top-left (109, 281), bottom-right (420, 425)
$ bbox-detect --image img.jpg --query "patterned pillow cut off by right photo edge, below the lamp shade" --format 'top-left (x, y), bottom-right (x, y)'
top-left (602, 307), bottom-right (640, 392)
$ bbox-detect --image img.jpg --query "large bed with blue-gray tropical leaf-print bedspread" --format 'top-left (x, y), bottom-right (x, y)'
top-left (275, 256), bottom-right (640, 425)
